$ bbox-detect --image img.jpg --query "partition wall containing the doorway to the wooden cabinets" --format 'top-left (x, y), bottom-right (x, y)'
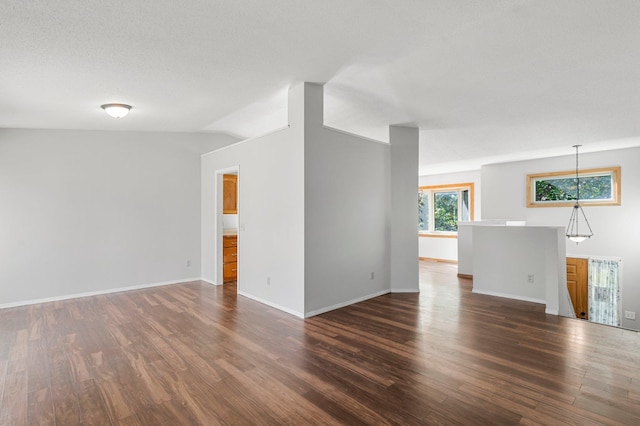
top-left (202, 85), bottom-right (305, 317)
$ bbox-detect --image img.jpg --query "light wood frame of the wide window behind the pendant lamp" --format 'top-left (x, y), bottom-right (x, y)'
top-left (527, 166), bottom-right (622, 208)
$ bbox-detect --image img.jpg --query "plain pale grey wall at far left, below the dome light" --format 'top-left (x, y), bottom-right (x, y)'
top-left (0, 129), bottom-right (233, 306)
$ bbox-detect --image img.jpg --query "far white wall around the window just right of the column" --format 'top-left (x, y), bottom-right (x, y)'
top-left (418, 170), bottom-right (482, 261)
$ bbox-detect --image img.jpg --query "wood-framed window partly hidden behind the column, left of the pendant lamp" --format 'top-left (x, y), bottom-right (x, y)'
top-left (418, 183), bottom-right (473, 237)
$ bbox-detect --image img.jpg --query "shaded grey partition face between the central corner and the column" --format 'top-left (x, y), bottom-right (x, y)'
top-left (304, 84), bottom-right (392, 316)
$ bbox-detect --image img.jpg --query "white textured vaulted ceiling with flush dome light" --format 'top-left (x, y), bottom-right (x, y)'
top-left (0, 0), bottom-right (640, 174)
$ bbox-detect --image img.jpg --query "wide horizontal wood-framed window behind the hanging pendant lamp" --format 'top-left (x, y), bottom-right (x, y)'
top-left (527, 167), bottom-right (621, 207)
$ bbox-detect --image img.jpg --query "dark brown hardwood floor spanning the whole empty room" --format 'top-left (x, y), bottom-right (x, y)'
top-left (0, 261), bottom-right (640, 425)
